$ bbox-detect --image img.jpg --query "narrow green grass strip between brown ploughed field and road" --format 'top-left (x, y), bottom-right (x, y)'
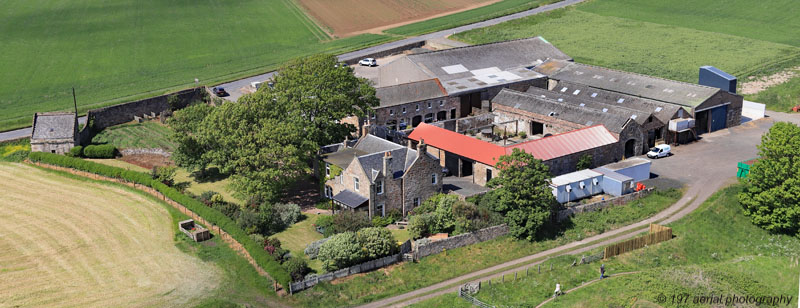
top-left (384, 0), bottom-right (560, 35)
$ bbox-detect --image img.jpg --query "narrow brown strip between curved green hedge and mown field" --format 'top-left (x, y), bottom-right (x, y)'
top-left (28, 162), bottom-right (277, 291)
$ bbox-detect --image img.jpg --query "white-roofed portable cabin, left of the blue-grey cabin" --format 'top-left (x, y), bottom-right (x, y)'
top-left (550, 169), bottom-right (603, 203)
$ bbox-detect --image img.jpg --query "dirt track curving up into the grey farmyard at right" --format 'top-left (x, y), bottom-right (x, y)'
top-left (359, 112), bottom-right (800, 308)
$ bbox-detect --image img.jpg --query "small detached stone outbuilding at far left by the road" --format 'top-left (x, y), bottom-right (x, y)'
top-left (31, 112), bottom-right (78, 154)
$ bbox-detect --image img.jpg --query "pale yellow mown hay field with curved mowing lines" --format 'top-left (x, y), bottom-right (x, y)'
top-left (0, 163), bottom-right (222, 307)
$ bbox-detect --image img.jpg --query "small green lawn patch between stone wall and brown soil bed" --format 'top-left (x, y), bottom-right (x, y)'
top-left (92, 121), bottom-right (175, 152)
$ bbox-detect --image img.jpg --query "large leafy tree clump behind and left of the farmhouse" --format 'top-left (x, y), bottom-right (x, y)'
top-left (173, 55), bottom-right (378, 201)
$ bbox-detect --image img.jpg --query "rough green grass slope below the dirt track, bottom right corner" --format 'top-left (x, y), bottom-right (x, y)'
top-left (418, 185), bottom-right (800, 307)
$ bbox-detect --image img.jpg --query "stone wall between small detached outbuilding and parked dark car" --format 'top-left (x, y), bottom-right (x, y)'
top-left (87, 87), bottom-right (205, 131)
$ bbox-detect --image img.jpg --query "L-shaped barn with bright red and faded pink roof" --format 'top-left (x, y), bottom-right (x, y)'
top-left (408, 123), bottom-right (619, 186)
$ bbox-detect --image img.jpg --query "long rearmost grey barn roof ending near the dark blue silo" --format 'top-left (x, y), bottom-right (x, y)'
top-left (534, 59), bottom-right (722, 108)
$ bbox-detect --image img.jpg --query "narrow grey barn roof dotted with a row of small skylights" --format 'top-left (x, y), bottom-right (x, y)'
top-left (548, 81), bottom-right (683, 123)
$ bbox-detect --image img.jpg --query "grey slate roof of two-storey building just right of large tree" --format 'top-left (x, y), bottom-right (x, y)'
top-left (375, 78), bottom-right (447, 107)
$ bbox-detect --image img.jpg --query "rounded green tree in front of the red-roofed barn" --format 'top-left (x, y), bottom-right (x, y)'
top-left (487, 149), bottom-right (556, 241)
